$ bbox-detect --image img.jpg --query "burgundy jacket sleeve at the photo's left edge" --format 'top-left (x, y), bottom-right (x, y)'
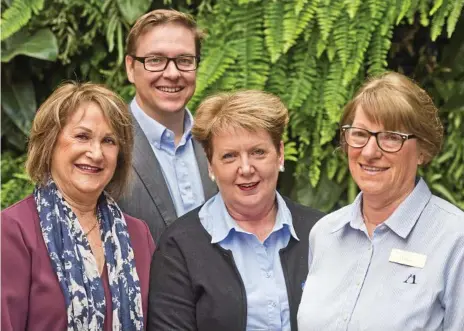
top-left (1, 213), bottom-right (31, 331)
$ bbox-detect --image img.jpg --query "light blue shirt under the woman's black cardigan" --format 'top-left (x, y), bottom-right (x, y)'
top-left (199, 192), bottom-right (299, 331)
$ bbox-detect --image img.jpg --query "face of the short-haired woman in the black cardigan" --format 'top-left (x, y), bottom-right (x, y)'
top-left (210, 129), bottom-right (284, 217)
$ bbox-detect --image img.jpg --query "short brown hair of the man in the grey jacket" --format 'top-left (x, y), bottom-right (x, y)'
top-left (126, 9), bottom-right (204, 56)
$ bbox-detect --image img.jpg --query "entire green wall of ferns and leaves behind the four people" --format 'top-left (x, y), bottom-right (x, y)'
top-left (1, 0), bottom-right (464, 211)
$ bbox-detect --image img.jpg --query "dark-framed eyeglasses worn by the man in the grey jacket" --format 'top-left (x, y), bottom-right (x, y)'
top-left (131, 55), bottom-right (200, 72)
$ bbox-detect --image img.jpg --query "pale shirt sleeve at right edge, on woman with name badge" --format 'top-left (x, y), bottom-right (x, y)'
top-left (443, 236), bottom-right (464, 330)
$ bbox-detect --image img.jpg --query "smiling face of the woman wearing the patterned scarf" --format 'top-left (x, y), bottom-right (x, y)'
top-left (51, 102), bottom-right (119, 201)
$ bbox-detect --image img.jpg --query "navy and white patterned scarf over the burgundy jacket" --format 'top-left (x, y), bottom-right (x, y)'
top-left (34, 179), bottom-right (143, 331)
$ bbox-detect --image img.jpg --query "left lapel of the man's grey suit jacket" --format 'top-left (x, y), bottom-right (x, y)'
top-left (132, 118), bottom-right (177, 225)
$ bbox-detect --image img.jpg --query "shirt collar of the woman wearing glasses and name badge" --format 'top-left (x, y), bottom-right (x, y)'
top-left (331, 178), bottom-right (432, 239)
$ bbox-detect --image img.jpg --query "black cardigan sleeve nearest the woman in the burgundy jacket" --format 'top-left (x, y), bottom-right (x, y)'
top-left (147, 237), bottom-right (197, 331)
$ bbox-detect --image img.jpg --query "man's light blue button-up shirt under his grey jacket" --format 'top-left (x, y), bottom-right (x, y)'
top-left (130, 98), bottom-right (205, 217)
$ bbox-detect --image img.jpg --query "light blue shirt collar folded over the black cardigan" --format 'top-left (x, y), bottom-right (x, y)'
top-left (198, 191), bottom-right (300, 244)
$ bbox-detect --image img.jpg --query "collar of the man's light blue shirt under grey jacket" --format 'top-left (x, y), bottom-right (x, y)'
top-left (130, 98), bottom-right (193, 148)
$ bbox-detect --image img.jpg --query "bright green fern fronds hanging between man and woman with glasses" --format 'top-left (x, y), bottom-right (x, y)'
top-left (189, 0), bottom-right (463, 210)
